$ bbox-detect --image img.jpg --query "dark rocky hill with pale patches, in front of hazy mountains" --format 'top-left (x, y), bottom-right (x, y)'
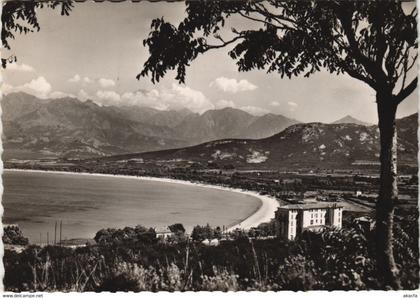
top-left (107, 114), bottom-right (417, 168)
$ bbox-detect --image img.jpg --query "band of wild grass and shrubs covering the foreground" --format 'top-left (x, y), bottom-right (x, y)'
top-left (4, 212), bottom-right (419, 291)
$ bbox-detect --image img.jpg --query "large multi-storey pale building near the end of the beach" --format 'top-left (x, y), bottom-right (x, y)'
top-left (275, 202), bottom-right (343, 240)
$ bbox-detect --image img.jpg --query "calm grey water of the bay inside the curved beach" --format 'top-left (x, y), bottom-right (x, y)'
top-left (2, 170), bottom-right (261, 243)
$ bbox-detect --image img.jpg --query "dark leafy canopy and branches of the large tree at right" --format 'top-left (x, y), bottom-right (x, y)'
top-left (137, 0), bottom-right (417, 102)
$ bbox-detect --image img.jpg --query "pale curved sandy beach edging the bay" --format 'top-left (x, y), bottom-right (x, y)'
top-left (3, 169), bottom-right (280, 231)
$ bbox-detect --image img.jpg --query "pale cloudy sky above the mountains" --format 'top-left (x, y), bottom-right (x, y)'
top-left (2, 1), bottom-right (418, 123)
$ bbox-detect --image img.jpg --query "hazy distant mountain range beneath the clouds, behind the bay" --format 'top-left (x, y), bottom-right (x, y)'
top-left (1, 92), bottom-right (298, 159)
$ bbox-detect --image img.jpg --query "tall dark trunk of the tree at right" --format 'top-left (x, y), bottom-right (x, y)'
top-left (376, 94), bottom-right (401, 289)
